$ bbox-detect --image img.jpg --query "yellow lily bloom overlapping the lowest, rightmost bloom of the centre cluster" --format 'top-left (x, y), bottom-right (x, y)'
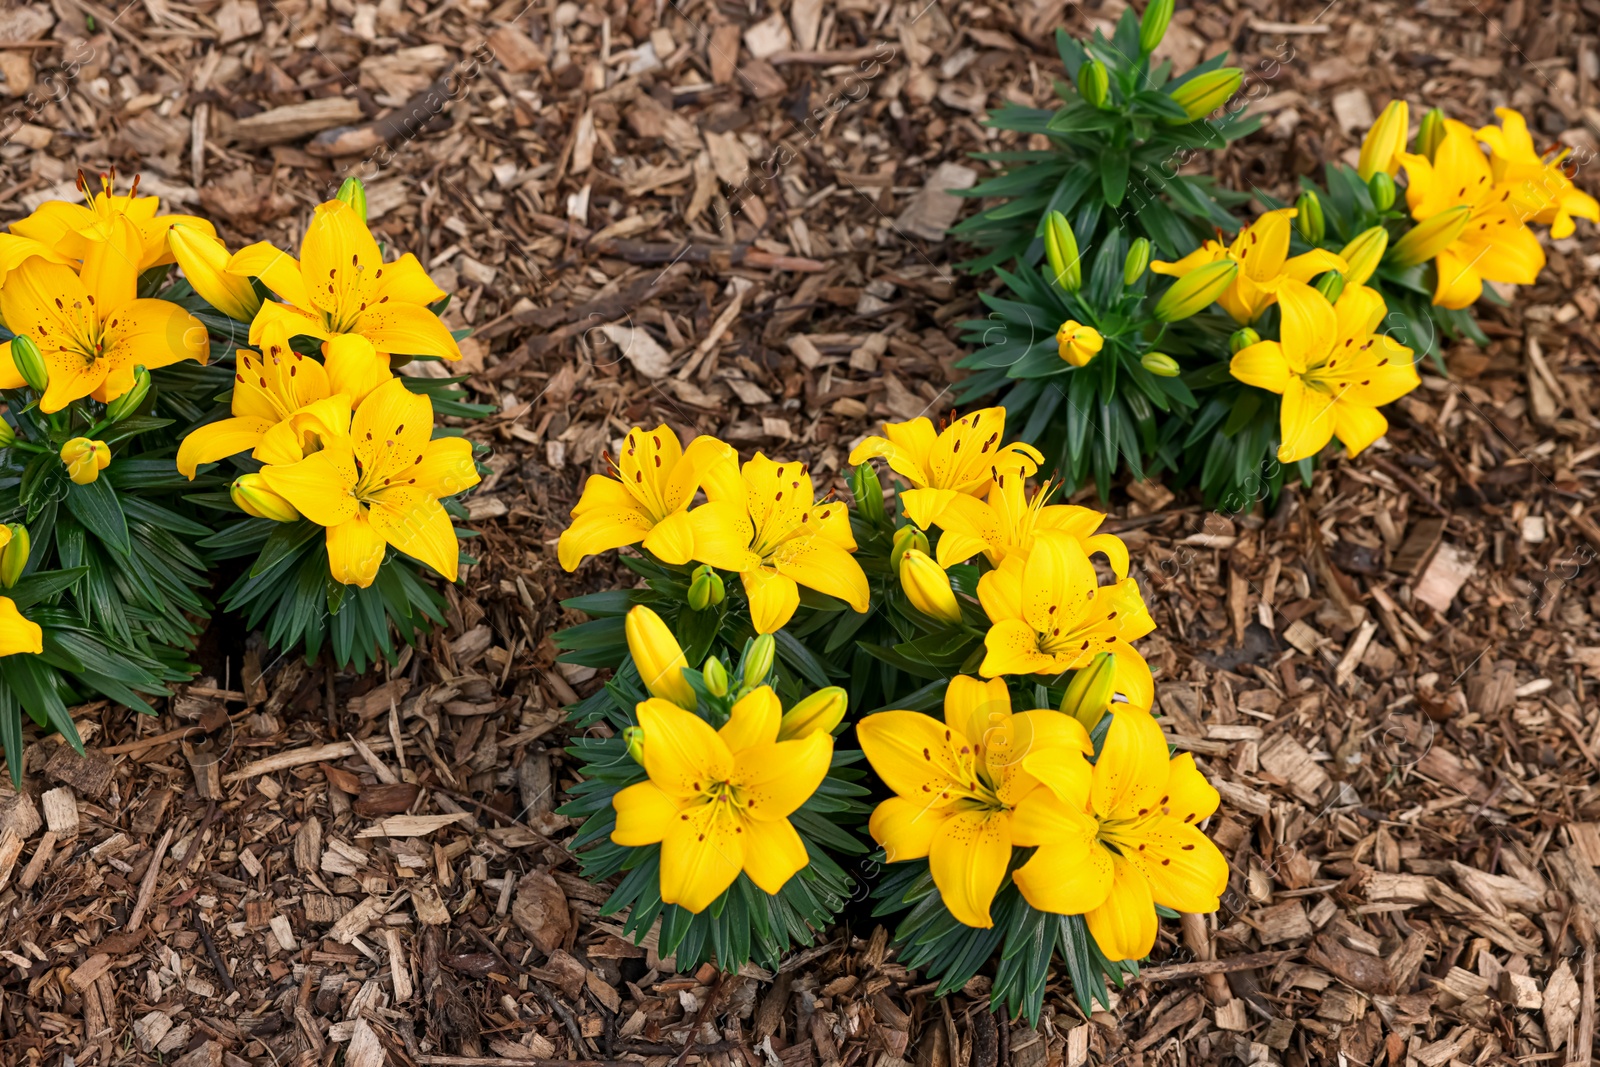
top-left (856, 675), bottom-right (1094, 928)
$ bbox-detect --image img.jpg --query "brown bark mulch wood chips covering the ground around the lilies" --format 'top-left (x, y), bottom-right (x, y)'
top-left (0, 0), bottom-right (1600, 1067)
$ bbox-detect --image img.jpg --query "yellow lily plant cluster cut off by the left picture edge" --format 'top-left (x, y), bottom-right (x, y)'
top-left (0, 174), bottom-right (478, 782)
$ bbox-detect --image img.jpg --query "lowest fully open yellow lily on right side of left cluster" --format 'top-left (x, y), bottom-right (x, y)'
top-left (261, 378), bottom-right (478, 589)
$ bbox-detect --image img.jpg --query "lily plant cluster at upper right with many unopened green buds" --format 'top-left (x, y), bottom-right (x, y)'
top-left (952, 0), bottom-right (1600, 510)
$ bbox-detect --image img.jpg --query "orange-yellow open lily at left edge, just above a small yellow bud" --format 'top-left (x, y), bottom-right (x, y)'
top-left (0, 214), bottom-right (211, 413)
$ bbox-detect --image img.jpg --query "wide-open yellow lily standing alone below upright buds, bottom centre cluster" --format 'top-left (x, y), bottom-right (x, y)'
top-left (611, 697), bottom-right (834, 913)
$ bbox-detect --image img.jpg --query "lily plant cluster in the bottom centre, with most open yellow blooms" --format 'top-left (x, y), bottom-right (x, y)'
top-left (557, 408), bottom-right (1229, 1017)
